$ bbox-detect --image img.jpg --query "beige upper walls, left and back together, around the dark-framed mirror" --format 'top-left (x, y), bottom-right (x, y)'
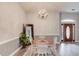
top-left (0, 3), bottom-right (59, 41)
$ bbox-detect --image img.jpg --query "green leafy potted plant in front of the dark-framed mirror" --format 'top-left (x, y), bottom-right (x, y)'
top-left (19, 32), bottom-right (30, 48)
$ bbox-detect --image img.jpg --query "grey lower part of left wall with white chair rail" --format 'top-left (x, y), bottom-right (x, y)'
top-left (0, 37), bottom-right (19, 56)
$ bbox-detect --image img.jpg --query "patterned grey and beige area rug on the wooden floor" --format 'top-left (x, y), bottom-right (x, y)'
top-left (25, 45), bottom-right (56, 56)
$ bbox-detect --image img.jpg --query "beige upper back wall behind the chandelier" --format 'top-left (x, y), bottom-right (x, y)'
top-left (27, 12), bottom-right (59, 35)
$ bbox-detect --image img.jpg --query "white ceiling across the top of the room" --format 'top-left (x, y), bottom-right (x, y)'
top-left (19, 2), bottom-right (79, 12)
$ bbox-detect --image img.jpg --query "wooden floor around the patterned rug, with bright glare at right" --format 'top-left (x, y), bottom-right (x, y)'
top-left (15, 39), bottom-right (79, 56)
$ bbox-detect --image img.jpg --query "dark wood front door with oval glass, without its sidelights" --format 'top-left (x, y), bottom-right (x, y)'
top-left (63, 24), bottom-right (73, 42)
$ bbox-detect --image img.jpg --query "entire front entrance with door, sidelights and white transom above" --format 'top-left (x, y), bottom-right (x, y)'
top-left (61, 20), bottom-right (75, 42)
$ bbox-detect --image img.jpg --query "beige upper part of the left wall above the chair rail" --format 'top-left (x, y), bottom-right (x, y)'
top-left (0, 3), bottom-right (26, 42)
